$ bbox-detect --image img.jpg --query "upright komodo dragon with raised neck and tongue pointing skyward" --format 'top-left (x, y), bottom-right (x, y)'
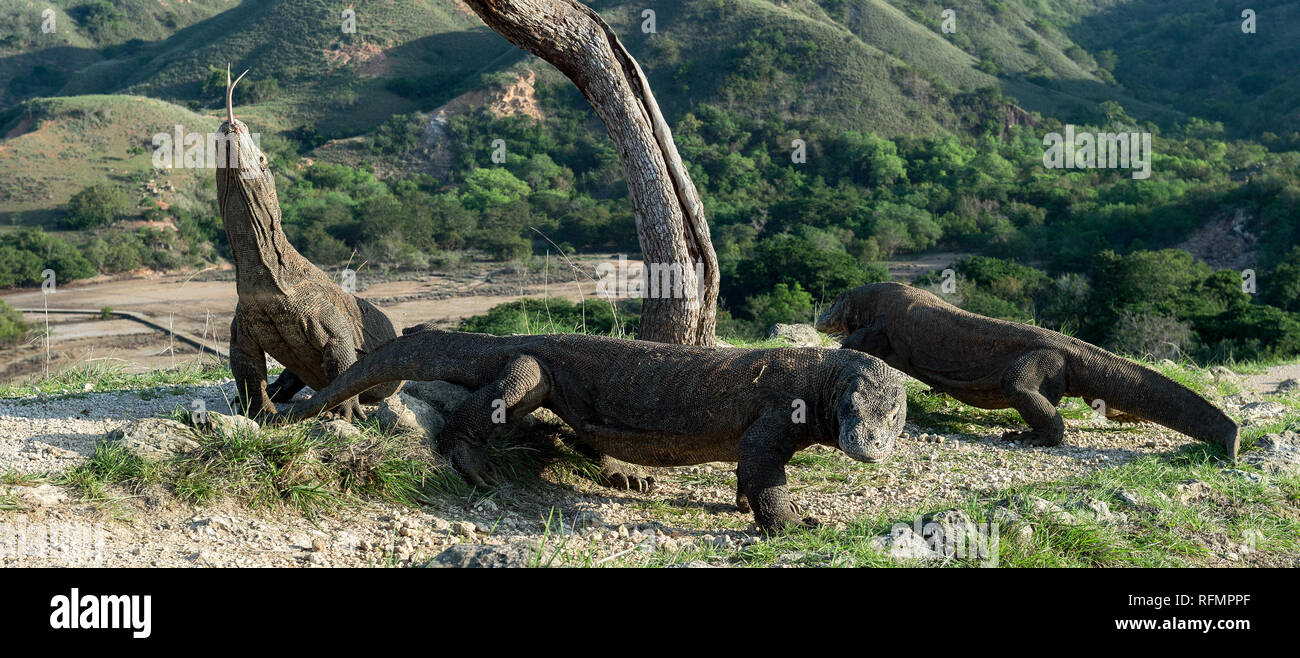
top-left (217, 69), bottom-right (402, 419)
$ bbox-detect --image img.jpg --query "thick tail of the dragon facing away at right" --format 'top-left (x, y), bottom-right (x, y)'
top-left (1070, 346), bottom-right (1240, 460)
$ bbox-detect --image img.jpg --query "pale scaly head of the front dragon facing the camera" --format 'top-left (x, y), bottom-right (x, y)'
top-left (836, 355), bottom-right (907, 462)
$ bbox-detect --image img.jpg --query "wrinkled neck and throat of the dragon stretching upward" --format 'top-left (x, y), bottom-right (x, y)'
top-left (217, 120), bottom-right (302, 294)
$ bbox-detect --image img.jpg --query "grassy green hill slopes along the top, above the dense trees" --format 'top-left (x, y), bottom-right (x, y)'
top-left (0, 0), bottom-right (1300, 138)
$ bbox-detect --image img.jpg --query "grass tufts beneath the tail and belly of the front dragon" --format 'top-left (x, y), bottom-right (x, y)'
top-left (60, 390), bottom-right (608, 518)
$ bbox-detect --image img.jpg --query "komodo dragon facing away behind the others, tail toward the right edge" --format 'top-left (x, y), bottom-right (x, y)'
top-left (816, 282), bottom-right (1240, 459)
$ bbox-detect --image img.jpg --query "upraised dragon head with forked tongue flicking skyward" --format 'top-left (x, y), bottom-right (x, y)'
top-left (217, 66), bottom-right (280, 230)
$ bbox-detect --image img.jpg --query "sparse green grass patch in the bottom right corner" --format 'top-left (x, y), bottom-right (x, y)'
top-left (637, 446), bottom-right (1300, 567)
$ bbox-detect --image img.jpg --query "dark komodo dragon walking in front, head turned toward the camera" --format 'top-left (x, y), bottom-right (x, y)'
top-left (277, 325), bottom-right (907, 532)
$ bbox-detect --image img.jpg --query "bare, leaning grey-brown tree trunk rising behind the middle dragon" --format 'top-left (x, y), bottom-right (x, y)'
top-left (465, 0), bottom-right (718, 345)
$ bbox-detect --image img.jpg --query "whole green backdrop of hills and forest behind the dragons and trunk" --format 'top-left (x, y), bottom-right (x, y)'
top-left (0, 0), bottom-right (1300, 359)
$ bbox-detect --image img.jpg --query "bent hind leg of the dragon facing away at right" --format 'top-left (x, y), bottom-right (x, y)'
top-left (1001, 350), bottom-right (1065, 446)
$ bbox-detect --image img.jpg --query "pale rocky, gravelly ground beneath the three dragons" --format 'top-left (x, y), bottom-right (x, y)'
top-left (0, 345), bottom-right (1300, 567)
